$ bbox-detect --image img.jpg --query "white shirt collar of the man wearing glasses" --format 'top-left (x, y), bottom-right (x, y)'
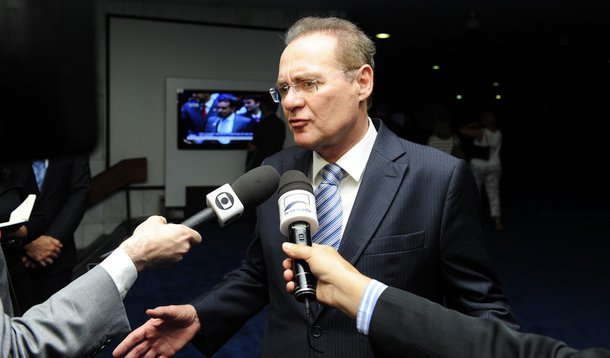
top-left (312, 117), bottom-right (377, 187)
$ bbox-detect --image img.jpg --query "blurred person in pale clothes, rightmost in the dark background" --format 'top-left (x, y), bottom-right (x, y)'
top-left (460, 111), bottom-right (503, 231)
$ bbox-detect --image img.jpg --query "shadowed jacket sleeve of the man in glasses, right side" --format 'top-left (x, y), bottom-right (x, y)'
top-left (440, 160), bottom-right (519, 329)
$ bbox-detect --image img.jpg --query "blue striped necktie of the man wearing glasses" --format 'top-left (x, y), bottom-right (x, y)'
top-left (313, 164), bottom-right (344, 249)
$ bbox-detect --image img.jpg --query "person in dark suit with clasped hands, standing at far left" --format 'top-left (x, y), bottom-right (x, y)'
top-left (7, 157), bottom-right (91, 312)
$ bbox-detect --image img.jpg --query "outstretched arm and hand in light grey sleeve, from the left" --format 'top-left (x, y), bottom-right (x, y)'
top-left (0, 216), bottom-right (201, 357)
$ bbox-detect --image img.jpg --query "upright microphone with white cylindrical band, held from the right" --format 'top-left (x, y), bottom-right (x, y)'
top-left (277, 170), bottom-right (318, 317)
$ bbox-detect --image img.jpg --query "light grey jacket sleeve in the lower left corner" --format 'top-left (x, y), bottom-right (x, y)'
top-left (0, 267), bottom-right (129, 357)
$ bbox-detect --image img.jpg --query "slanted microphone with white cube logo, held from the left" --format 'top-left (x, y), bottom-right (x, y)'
top-left (182, 165), bottom-right (280, 229)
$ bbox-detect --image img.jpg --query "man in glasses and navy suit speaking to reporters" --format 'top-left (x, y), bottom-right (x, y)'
top-left (115, 18), bottom-right (518, 357)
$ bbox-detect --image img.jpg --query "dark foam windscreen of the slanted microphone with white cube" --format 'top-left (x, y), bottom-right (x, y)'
top-left (231, 165), bottom-right (280, 208)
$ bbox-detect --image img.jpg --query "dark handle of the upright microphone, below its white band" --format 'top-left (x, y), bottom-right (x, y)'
top-left (289, 221), bottom-right (317, 304)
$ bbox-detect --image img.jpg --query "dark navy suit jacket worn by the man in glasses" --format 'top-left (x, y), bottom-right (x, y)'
top-left (191, 120), bottom-right (517, 358)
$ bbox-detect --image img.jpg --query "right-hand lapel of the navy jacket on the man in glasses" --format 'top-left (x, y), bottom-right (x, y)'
top-left (339, 123), bottom-right (408, 264)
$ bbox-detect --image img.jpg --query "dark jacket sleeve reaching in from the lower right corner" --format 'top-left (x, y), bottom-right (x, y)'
top-left (369, 287), bottom-right (610, 358)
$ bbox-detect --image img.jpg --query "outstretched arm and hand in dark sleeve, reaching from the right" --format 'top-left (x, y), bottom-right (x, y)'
top-left (283, 243), bottom-right (610, 358)
